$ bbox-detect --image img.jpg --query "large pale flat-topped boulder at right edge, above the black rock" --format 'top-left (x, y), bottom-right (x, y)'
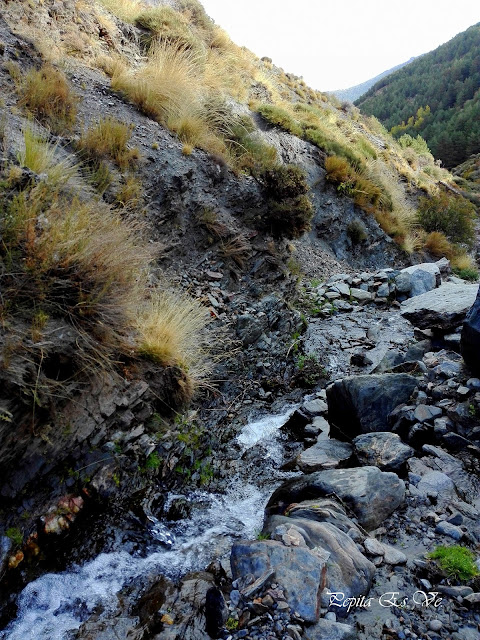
top-left (400, 283), bottom-right (478, 332)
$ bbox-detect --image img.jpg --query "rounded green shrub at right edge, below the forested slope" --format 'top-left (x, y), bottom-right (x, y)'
top-left (418, 193), bottom-right (475, 247)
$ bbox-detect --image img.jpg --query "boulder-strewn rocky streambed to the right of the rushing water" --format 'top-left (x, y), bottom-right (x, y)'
top-left (3, 262), bottom-right (480, 640)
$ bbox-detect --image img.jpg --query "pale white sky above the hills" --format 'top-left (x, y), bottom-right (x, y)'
top-left (201, 0), bottom-right (480, 91)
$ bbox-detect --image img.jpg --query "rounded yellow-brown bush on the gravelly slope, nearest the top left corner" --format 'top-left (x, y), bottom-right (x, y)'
top-left (17, 65), bottom-right (78, 133)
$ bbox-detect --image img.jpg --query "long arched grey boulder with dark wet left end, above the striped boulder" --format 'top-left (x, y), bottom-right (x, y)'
top-left (266, 467), bottom-right (405, 529)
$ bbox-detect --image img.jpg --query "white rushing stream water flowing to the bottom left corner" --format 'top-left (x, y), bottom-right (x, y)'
top-left (0, 407), bottom-right (296, 640)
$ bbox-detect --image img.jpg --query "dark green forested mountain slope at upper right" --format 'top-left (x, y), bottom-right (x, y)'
top-left (356, 23), bottom-right (480, 167)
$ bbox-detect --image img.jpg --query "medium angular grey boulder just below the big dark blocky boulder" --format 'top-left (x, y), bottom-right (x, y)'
top-left (353, 431), bottom-right (415, 471)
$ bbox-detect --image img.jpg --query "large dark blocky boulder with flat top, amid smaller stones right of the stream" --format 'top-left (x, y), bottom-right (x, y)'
top-left (327, 373), bottom-right (417, 438)
